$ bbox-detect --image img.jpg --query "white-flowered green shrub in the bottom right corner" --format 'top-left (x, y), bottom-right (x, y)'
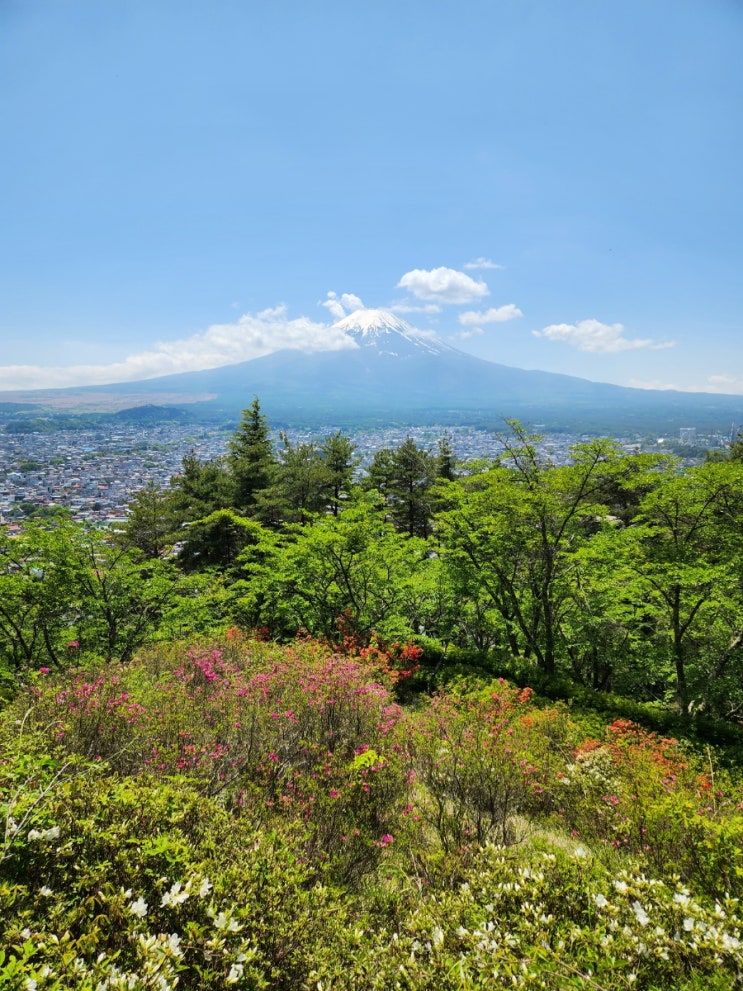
top-left (313, 845), bottom-right (743, 991)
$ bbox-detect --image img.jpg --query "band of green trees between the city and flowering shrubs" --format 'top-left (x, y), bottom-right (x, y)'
top-left (0, 400), bottom-right (743, 720)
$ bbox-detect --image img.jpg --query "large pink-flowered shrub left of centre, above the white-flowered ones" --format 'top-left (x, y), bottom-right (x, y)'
top-left (14, 634), bottom-right (416, 881)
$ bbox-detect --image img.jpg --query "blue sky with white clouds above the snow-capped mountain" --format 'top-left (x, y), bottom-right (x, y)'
top-left (0, 0), bottom-right (743, 393)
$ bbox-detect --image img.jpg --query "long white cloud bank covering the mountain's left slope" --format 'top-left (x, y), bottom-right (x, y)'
top-left (0, 306), bottom-right (357, 390)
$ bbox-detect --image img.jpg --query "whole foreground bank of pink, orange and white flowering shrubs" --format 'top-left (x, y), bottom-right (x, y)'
top-left (0, 630), bottom-right (743, 991)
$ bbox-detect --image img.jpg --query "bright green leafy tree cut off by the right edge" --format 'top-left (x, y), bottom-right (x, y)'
top-left (583, 461), bottom-right (743, 717)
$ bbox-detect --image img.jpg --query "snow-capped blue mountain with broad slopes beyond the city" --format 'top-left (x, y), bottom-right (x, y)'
top-left (0, 309), bottom-right (743, 433)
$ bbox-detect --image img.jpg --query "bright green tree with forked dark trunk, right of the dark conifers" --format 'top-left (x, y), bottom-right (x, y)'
top-left (438, 423), bottom-right (620, 674)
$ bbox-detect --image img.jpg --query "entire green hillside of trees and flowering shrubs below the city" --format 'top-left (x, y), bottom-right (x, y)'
top-left (0, 401), bottom-right (743, 991)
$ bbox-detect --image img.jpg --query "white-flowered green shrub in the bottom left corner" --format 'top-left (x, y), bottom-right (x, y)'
top-left (0, 768), bottom-right (342, 991)
